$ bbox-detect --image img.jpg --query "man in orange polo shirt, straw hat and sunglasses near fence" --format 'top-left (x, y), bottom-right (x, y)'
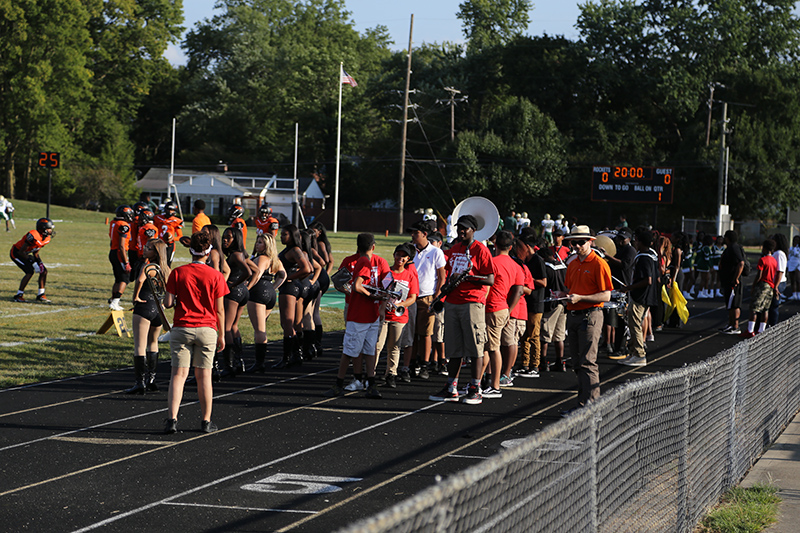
top-left (562, 226), bottom-right (614, 416)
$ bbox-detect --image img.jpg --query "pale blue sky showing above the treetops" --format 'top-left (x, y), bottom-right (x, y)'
top-left (166, 0), bottom-right (584, 65)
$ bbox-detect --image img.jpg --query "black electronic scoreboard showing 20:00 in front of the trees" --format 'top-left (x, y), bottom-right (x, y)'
top-left (592, 166), bottom-right (675, 204)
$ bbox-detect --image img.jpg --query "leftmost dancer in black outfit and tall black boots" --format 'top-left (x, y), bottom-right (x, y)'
top-left (125, 239), bottom-right (170, 394)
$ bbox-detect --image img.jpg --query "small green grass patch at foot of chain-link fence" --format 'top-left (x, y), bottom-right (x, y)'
top-left (697, 485), bottom-right (781, 533)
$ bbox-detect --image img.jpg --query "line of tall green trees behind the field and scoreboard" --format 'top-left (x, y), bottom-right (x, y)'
top-left (0, 0), bottom-right (800, 229)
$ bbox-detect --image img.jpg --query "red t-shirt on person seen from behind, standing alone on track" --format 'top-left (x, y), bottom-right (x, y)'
top-left (167, 263), bottom-right (230, 329)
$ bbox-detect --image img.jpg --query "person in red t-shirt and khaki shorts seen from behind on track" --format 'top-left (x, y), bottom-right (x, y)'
top-left (164, 232), bottom-right (228, 433)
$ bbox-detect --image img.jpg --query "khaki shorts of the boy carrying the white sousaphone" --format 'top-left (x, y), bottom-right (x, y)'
top-left (444, 302), bottom-right (486, 359)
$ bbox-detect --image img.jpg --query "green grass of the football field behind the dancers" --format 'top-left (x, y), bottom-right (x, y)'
top-left (0, 200), bottom-right (407, 388)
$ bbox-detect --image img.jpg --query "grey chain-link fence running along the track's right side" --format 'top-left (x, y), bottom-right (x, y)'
top-left (342, 315), bottom-right (800, 533)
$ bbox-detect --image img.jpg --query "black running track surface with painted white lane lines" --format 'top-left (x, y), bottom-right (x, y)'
top-left (0, 299), bottom-right (798, 532)
